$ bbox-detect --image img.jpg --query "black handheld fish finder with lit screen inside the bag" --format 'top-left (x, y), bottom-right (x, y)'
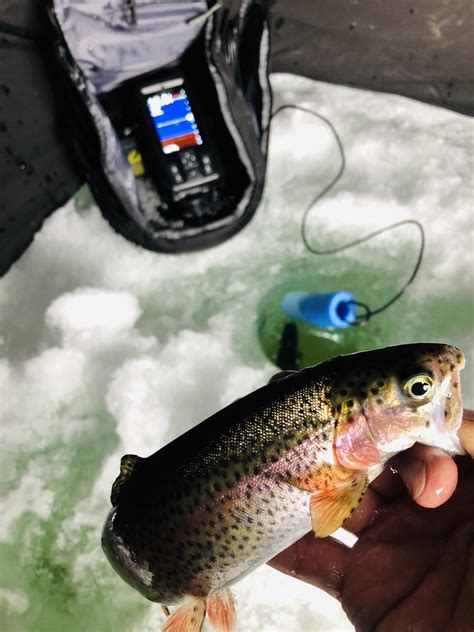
top-left (135, 76), bottom-right (222, 199)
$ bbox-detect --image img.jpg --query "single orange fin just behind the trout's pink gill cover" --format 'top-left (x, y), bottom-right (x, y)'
top-left (309, 472), bottom-right (369, 538)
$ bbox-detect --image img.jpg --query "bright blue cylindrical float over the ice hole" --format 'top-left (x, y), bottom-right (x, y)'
top-left (281, 290), bottom-right (356, 329)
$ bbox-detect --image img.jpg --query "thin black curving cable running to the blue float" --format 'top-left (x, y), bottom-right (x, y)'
top-left (270, 104), bottom-right (425, 325)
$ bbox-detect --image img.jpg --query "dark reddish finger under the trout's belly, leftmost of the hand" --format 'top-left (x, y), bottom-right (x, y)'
top-left (268, 533), bottom-right (350, 598)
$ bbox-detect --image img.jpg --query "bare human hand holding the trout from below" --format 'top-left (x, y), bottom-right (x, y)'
top-left (269, 411), bottom-right (474, 632)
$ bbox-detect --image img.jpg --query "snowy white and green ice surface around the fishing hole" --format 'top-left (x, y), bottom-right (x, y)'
top-left (0, 75), bottom-right (474, 632)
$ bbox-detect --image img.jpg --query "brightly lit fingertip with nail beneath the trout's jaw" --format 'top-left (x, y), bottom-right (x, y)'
top-left (396, 444), bottom-right (458, 508)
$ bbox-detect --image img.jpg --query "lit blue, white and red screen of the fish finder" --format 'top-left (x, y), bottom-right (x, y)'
top-left (146, 85), bottom-right (202, 154)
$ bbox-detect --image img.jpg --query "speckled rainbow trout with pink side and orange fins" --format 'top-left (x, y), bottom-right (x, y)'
top-left (102, 344), bottom-right (464, 632)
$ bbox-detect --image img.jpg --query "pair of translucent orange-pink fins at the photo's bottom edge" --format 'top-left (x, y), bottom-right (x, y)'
top-left (161, 588), bottom-right (235, 632)
